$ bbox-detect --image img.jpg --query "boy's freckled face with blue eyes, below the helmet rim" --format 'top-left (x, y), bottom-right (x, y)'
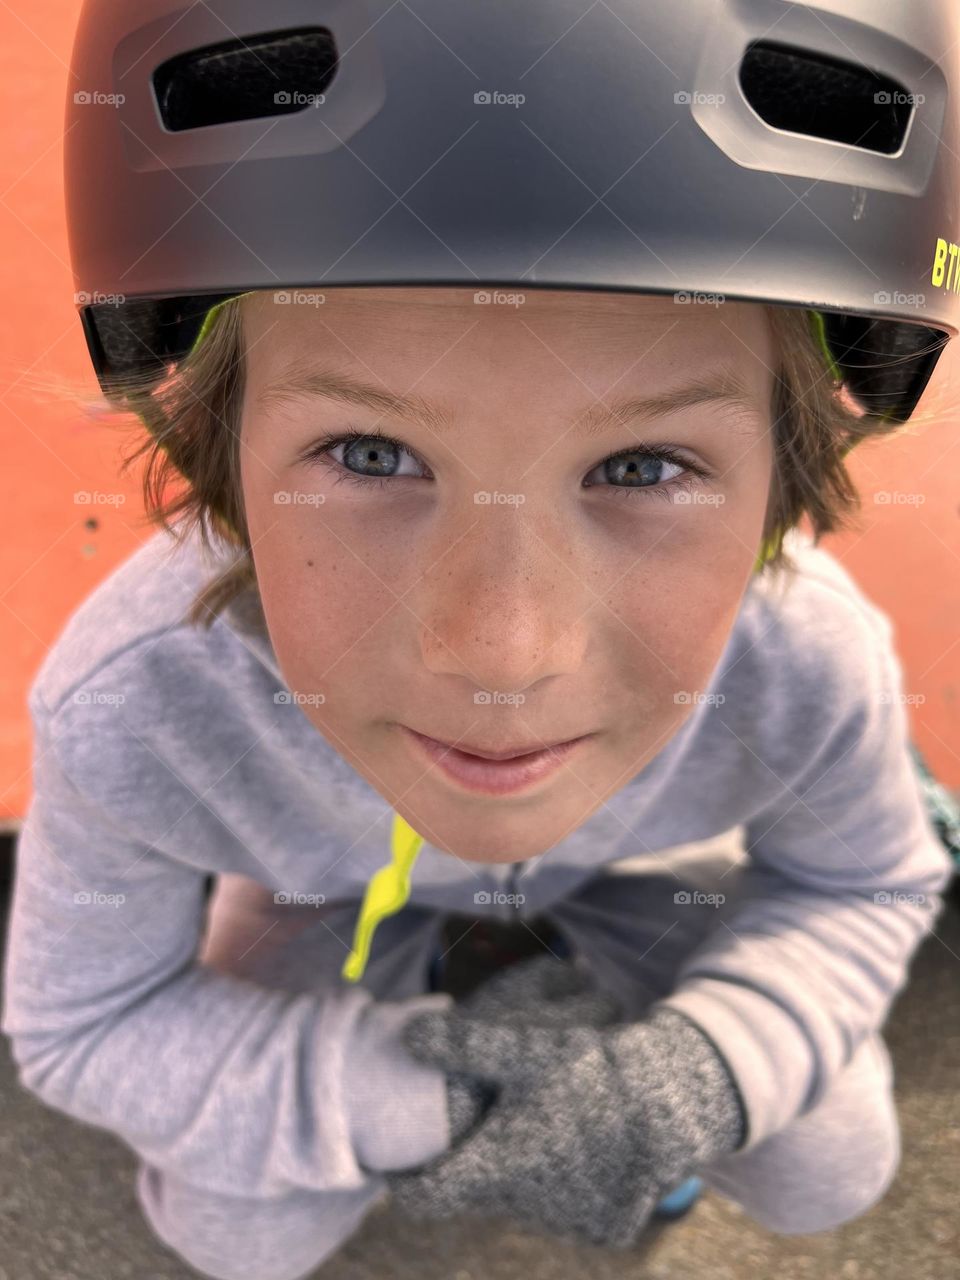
top-left (241, 288), bottom-right (774, 863)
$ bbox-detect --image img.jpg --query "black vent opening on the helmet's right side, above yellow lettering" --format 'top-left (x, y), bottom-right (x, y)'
top-left (740, 40), bottom-right (914, 155)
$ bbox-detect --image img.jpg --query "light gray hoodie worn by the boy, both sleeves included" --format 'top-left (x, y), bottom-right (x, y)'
top-left (0, 519), bottom-right (951, 1197)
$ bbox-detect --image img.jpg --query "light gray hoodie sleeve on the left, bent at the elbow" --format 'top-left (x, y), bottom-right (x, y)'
top-left (0, 698), bottom-right (451, 1197)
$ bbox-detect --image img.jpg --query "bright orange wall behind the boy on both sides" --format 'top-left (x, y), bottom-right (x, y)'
top-left (0, 0), bottom-right (960, 818)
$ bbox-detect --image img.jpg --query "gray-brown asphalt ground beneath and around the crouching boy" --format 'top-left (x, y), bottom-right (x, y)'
top-left (0, 839), bottom-right (960, 1280)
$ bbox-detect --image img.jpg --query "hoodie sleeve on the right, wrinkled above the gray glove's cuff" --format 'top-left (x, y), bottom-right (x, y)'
top-left (660, 593), bottom-right (952, 1151)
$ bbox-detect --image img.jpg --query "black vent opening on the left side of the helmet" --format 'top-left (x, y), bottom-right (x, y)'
top-left (154, 27), bottom-right (337, 133)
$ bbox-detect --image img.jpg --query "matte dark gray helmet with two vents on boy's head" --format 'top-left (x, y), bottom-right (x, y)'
top-left (64, 0), bottom-right (960, 421)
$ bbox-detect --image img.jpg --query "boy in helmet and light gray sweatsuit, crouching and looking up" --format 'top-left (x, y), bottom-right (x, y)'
top-left (3, 0), bottom-right (960, 1280)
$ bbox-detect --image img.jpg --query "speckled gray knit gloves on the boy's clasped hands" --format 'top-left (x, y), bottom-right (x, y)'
top-left (387, 974), bottom-right (745, 1248)
